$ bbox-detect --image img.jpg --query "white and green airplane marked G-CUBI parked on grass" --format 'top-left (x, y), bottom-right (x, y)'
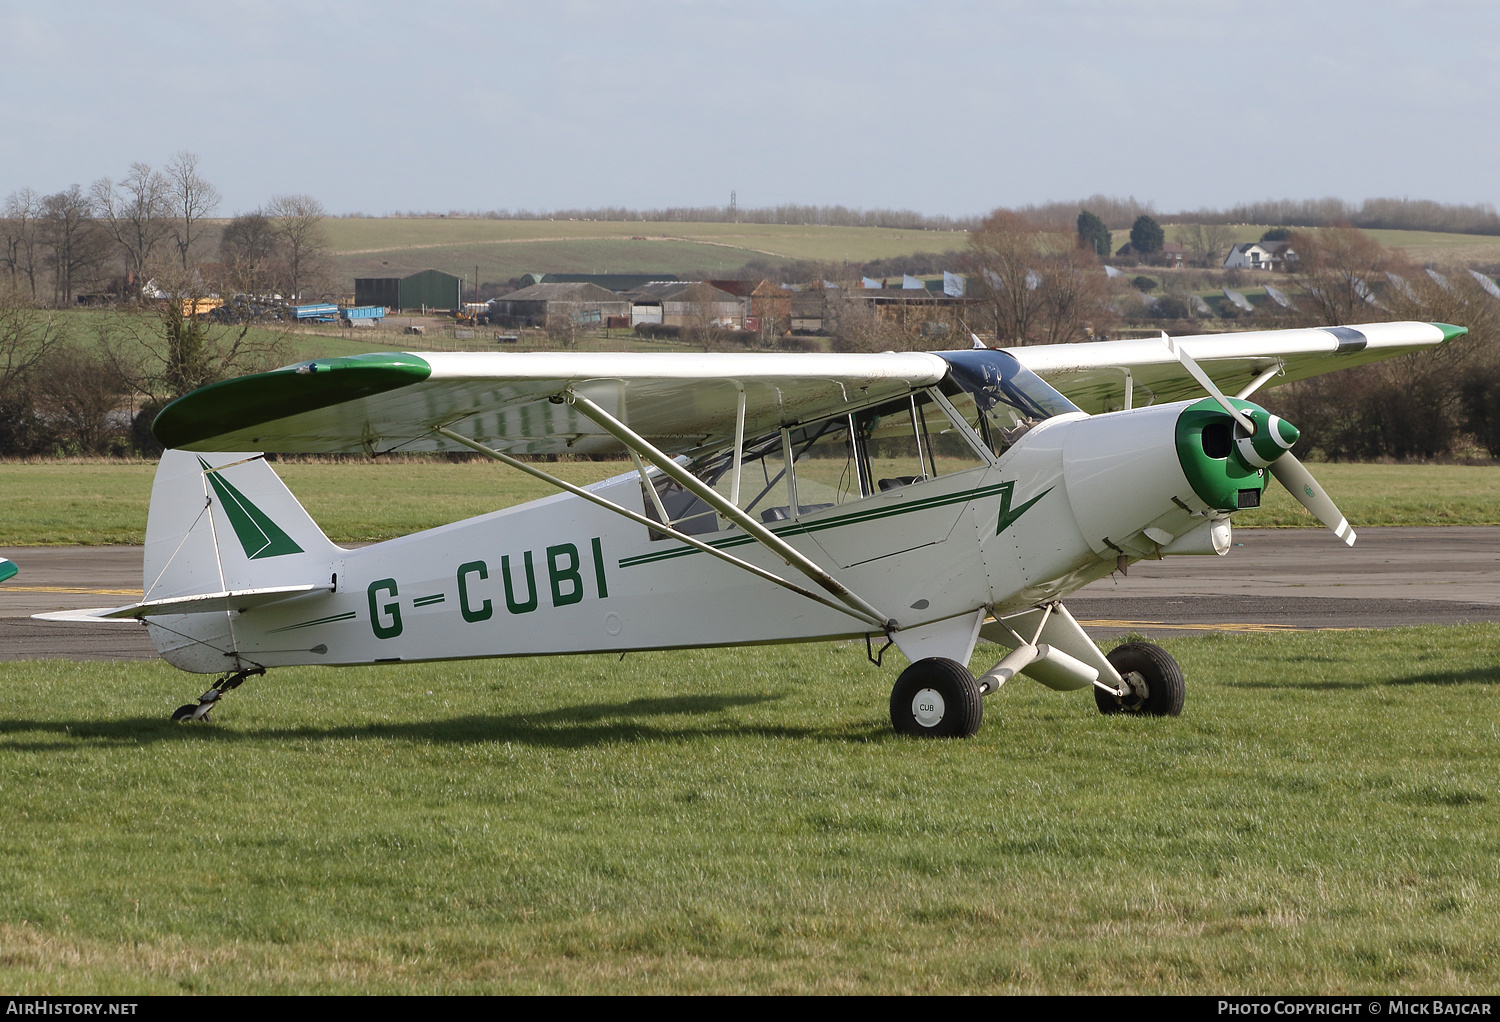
top-left (35, 323), bottom-right (1466, 735)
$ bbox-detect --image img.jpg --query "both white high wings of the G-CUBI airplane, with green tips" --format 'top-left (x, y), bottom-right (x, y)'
top-left (153, 316), bottom-right (1466, 455)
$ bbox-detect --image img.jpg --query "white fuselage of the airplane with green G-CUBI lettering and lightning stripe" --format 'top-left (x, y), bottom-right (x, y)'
top-left (143, 393), bottom-right (1242, 672)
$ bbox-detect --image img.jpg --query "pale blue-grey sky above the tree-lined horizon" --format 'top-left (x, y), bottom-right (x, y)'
top-left (0, 0), bottom-right (1500, 216)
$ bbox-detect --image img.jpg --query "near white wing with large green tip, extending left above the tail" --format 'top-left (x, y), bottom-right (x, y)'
top-left (152, 351), bottom-right (948, 455)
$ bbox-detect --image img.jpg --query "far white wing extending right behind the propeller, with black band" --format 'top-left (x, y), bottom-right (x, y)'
top-left (1010, 323), bottom-right (1469, 414)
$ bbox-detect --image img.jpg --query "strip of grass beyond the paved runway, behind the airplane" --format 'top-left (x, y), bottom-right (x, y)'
top-left (0, 461), bottom-right (1500, 546)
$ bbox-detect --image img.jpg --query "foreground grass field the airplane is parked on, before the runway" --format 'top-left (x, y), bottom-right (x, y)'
top-left (0, 626), bottom-right (1500, 995)
